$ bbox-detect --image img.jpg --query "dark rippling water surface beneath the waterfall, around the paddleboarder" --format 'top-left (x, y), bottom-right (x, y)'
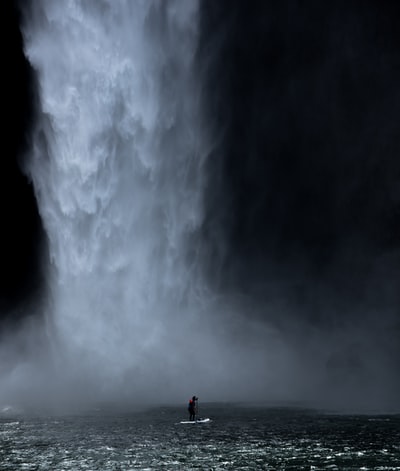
top-left (0, 405), bottom-right (400, 471)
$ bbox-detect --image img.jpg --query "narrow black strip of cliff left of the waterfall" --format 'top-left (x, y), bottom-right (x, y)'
top-left (0, 1), bottom-right (45, 320)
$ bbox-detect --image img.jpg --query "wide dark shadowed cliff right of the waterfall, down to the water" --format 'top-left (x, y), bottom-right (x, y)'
top-left (198, 0), bottom-right (400, 405)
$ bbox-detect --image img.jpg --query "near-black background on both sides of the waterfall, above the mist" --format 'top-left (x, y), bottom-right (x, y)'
top-left (0, 0), bottom-right (400, 342)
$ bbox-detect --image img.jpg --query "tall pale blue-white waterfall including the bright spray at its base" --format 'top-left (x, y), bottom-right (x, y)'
top-left (10, 0), bottom-right (287, 410)
